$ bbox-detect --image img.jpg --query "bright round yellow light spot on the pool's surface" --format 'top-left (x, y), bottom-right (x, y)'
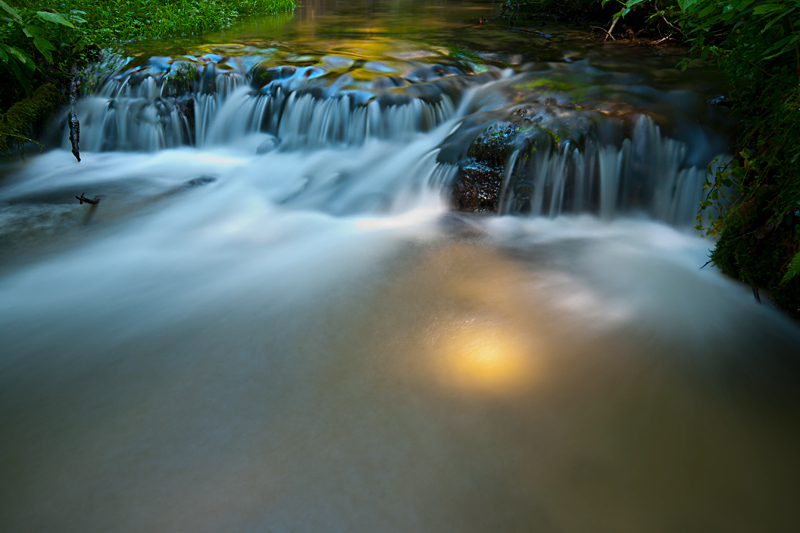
top-left (439, 324), bottom-right (538, 392)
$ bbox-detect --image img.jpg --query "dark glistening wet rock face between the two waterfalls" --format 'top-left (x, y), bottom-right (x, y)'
top-left (452, 160), bottom-right (503, 213)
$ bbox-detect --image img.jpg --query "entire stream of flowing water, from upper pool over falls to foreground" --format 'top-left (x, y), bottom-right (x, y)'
top-left (0, 0), bottom-right (800, 532)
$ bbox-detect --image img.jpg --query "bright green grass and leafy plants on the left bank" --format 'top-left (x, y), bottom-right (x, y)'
top-left (0, 0), bottom-right (295, 151)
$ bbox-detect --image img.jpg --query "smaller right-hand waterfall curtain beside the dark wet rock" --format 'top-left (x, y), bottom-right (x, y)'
top-left (500, 115), bottom-right (716, 225)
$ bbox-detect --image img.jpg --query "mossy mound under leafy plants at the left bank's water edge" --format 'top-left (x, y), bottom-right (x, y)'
top-left (0, 83), bottom-right (65, 152)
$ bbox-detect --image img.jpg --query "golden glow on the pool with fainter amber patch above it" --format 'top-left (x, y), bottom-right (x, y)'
top-left (406, 244), bottom-right (547, 395)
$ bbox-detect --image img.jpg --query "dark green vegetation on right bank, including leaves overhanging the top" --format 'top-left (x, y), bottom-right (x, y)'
top-left (506, 0), bottom-right (800, 317)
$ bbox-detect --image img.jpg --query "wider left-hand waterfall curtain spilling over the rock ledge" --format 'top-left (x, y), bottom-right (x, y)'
top-left (72, 65), bottom-right (455, 152)
